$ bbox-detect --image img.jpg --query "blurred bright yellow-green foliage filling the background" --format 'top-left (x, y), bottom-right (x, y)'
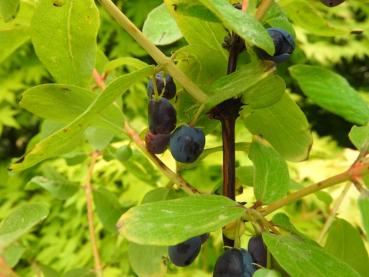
top-left (0, 0), bottom-right (369, 276)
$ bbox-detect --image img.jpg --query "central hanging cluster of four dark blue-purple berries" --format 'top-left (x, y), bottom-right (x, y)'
top-left (145, 72), bottom-right (205, 163)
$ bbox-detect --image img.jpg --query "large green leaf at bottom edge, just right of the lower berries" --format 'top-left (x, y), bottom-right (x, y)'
top-left (263, 233), bottom-right (360, 277)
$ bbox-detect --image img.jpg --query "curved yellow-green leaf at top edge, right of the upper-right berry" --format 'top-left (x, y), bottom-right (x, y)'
top-left (281, 0), bottom-right (350, 37)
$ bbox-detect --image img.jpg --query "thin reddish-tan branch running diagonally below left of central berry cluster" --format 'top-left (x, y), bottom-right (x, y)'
top-left (124, 121), bottom-right (200, 195)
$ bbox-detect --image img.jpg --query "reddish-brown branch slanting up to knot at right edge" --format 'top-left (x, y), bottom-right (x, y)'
top-left (260, 161), bottom-right (369, 216)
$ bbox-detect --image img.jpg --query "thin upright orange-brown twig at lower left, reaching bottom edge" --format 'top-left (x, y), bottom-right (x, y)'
top-left (84, 151), bottom-right (103, 277)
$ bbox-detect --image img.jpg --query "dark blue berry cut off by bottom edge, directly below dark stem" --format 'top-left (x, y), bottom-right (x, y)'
top-left (213, 248), bottom-right (255, 277)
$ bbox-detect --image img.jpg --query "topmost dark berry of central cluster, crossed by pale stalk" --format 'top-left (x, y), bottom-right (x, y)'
top-left (147, 71), bottom-right (176, 99)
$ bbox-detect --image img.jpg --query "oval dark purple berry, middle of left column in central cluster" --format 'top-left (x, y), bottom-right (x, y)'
top-left (148, 98), bottom-right (177, 134)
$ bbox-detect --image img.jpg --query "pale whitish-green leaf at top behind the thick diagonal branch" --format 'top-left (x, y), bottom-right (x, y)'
top-left (142, 4), bottom-right (182, 45)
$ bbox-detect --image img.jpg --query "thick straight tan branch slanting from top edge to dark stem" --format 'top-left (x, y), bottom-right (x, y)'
top-left (99, 0), bottom-right (208, 104)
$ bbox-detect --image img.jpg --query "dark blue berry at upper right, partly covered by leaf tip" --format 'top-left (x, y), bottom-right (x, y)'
top-left (257, 28), bottom-right (295, 63)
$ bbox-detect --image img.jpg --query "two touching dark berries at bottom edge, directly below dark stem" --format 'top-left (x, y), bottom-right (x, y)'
top-left (213, 236), bottom-right (267, 277)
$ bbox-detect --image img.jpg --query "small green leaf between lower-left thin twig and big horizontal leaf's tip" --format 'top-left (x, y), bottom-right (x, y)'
top-left (93, 185), bottom-right (123, 234)
